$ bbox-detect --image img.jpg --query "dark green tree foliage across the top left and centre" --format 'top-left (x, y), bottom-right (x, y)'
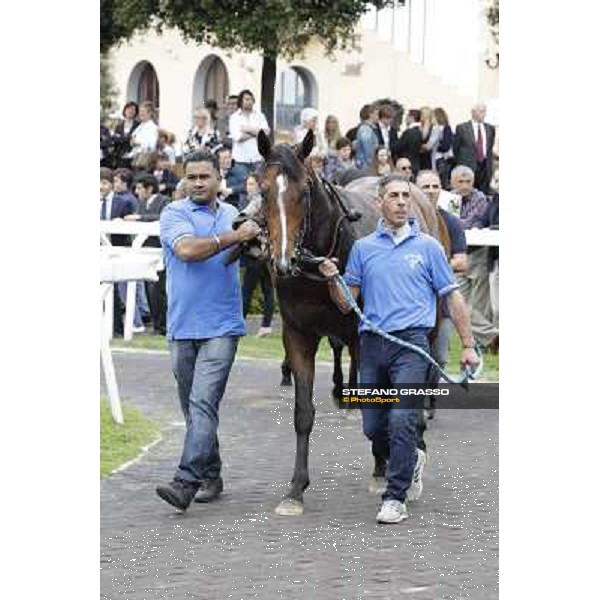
top-left (101, 0), bottom-right (393, 58)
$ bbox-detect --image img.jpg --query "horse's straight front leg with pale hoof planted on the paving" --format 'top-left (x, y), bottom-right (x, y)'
top-left (275, 327), bottom-right (319, 516)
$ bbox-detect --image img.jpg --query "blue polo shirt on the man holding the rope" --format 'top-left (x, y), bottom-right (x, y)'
top-left (344, 219), bottom-right (458, 333)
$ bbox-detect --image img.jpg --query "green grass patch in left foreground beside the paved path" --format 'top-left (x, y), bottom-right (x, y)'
top-left (100, 399), bottom-right (158, 477)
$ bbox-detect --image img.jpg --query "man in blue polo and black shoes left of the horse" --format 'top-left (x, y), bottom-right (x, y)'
top-left (156, 151), bottom-right (259, 510)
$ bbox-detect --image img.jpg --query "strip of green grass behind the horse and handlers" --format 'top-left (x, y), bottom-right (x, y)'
top-left (112, 334), bottom-right (500, 381)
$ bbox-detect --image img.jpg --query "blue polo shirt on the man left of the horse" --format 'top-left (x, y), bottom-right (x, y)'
top-left (160, 198), bottom-right (246, 340)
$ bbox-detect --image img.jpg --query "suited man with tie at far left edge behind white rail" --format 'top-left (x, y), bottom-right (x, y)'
top-left (100, 167), bottom-right (138, 336)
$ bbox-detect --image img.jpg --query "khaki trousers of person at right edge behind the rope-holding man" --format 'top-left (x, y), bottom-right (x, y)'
top-left (456, 248), bottom-right (498, 346)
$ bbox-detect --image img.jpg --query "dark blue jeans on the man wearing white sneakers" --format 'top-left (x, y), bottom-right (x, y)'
top-left (359, 328), bottom-right (429, 502)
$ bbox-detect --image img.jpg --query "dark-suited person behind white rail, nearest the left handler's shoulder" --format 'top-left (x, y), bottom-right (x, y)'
top-left (125, 173), bottom-right (171, 335)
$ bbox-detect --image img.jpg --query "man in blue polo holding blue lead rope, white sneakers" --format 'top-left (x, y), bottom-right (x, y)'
top-left (320, 174), bottom-right (478, 523)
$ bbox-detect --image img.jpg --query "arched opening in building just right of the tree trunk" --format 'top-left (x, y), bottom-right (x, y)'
top-left (275, 67), bottom-right (318, 132)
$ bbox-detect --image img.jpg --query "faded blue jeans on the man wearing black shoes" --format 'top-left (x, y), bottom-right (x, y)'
top-left (169, 337), bottom-right (238, 485)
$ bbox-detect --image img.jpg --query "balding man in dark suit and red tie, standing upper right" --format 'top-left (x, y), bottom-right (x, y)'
top-left (452, 102), bottom-right (496, 194)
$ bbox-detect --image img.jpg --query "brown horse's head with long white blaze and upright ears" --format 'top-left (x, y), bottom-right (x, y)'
top-left (258, 130), bottom-right (315, 277)
